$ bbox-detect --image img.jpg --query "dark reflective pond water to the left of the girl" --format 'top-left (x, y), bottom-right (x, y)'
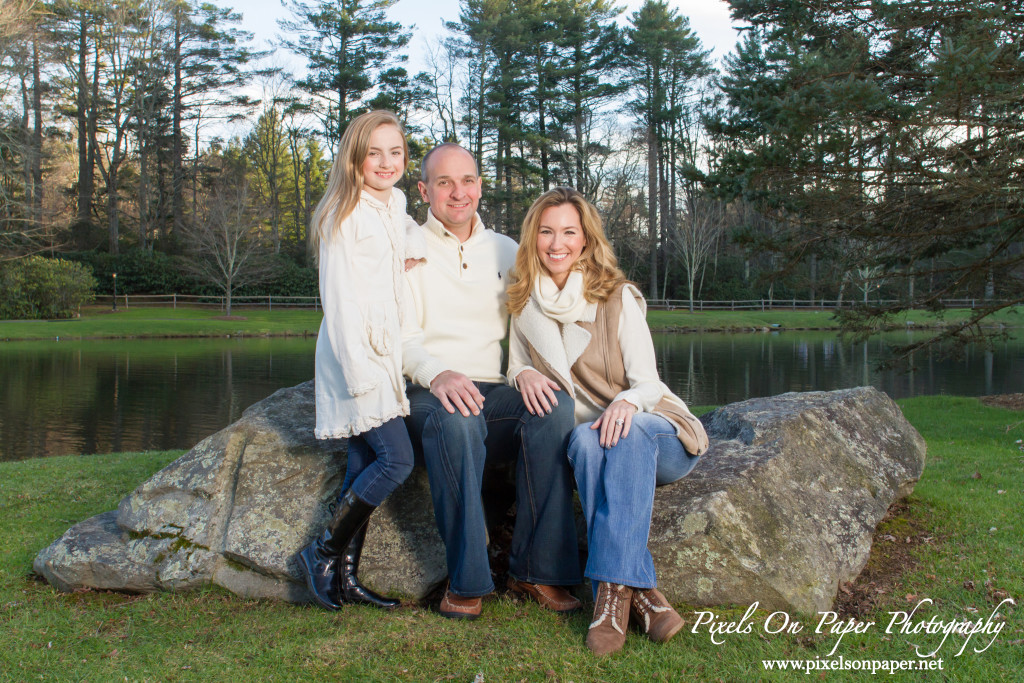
top-left (0, 339), bottom-right (315, 460)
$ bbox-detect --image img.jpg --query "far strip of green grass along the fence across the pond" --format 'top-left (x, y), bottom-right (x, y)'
top-left (0, 307), bottom-right (1024, 341)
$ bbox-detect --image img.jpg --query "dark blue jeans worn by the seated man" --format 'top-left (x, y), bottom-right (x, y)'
top-left (407, 382), bottom-right (583, 597)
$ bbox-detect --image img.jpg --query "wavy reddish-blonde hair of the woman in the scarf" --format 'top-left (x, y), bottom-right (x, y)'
top-left (507, 187), bottom-right (626, 315)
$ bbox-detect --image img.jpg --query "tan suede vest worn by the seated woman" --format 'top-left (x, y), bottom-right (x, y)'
top-left (530, 287), bottom-right (708, 456)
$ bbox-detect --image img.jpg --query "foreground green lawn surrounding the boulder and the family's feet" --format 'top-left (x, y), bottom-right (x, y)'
top-left (0, 396), bottom-right (1024, 683)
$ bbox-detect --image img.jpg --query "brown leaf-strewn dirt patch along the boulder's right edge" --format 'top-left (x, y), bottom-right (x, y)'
top-left (834, 499), bottom-right (935, 618)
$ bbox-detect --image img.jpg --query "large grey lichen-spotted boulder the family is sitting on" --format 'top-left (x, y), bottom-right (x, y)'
top-left (34, 382), bottom-right (925, 611)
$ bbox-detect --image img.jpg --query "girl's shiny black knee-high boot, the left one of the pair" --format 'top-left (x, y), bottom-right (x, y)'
top-left (299, 489), bottom-right (376, 609)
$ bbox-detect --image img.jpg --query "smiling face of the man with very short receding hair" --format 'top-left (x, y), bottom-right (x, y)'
top-left (419, 147), bottom-right (480, 234)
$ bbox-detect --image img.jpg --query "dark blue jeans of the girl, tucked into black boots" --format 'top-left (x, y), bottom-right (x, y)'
top-left (341, 418), bottom-right (414, 506)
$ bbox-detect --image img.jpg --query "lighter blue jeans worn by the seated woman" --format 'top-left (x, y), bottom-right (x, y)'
top-left (568, 413), bottom-right (697, 590)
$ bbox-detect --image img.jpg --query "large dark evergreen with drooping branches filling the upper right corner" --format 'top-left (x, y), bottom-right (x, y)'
top-left (710, 0), bottom-right (1024, 352)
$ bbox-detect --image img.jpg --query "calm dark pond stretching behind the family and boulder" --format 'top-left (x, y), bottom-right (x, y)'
top-left (0, 332), bottom-right (1024, 461)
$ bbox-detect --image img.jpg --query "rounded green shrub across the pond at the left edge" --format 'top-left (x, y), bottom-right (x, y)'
top-left (0, 256), bottom-right (96, 319)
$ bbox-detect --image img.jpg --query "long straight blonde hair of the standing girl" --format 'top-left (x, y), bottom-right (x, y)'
top-left (309, 110), bottom-right (409, 255)
